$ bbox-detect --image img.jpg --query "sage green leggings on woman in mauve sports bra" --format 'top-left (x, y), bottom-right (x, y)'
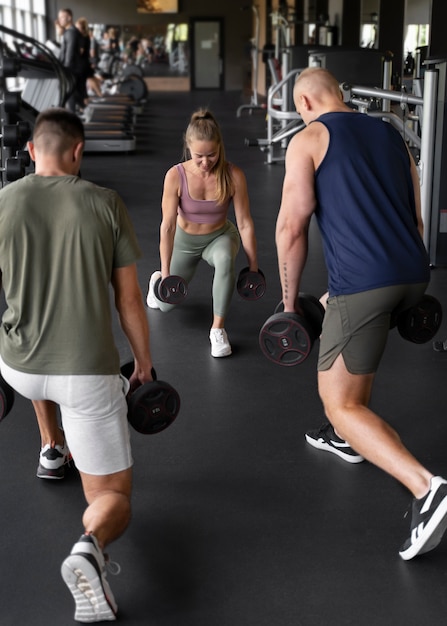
top-left (159, 221), bottom-right (241, 317)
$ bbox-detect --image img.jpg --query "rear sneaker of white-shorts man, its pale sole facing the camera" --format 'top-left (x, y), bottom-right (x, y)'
top-left (61, 534), bottom-right (119, 623)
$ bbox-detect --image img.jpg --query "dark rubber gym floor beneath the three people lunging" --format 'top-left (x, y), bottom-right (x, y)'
top-left (0, 92), bottom-right (447, 626)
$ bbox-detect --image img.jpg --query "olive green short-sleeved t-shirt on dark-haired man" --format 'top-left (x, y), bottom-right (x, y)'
top-left (0, 174), bottom-right (140, 375)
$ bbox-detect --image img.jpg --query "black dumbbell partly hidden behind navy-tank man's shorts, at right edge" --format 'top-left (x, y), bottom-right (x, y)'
top-left (390, 293), bottom-right (442, 344)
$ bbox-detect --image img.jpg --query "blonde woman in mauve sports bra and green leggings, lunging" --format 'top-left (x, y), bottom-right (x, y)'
top-left (147, 109), bottom-right (258, 357)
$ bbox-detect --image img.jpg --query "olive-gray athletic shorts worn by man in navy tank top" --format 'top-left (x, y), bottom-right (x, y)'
top-left (318, 283), bottom-right (427, 374)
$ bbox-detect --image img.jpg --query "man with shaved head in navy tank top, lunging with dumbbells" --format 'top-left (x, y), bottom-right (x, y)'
top-left (276, 67), bottom-right (447, 560)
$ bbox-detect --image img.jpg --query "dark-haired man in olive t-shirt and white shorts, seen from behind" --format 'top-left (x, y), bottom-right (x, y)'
top-left (0, 109), bottom-right (152, 622)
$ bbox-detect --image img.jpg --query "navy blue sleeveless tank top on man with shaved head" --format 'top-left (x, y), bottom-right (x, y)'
top-left (315, 112), bottom-right (430, 295)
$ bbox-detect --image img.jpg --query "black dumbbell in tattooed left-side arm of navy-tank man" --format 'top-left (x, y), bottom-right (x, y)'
top-left (259, 293), bottom-right (324, 367)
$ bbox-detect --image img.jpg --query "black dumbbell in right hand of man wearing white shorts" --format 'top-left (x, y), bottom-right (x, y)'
top-left (121, 361), bottom-right (180, 435)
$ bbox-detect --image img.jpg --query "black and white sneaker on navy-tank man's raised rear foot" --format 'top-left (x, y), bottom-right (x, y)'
top-left (399, 476), bottom-right (447, 561)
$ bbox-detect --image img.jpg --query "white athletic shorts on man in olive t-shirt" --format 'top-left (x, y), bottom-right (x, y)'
top-left (0, 360), bottom-right (133, 476)
